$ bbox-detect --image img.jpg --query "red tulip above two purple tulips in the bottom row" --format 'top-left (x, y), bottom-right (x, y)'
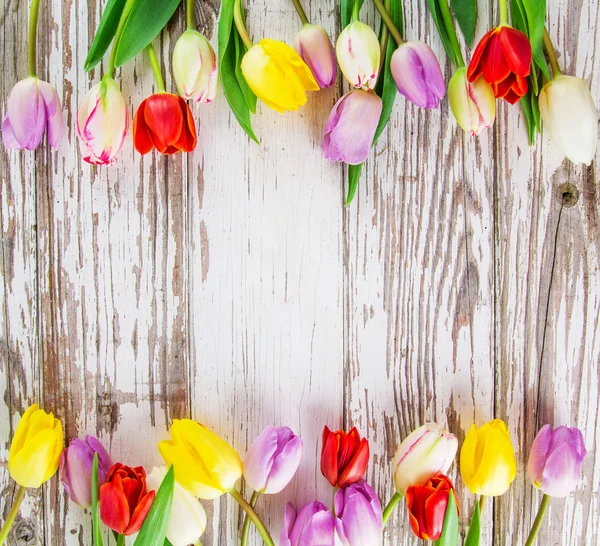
top-left (321, 427), bottom-right (370, 489)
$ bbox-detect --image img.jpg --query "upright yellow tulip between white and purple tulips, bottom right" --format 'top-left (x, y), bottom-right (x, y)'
top-left (460, 419), bottom-right (517, 497)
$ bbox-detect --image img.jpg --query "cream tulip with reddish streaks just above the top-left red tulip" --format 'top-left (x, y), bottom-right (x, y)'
top-left (173, 30), bottom-right (217, 103)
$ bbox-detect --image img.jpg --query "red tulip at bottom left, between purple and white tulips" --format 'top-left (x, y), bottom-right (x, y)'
top-left (100, 463), bottom-right (156, 536)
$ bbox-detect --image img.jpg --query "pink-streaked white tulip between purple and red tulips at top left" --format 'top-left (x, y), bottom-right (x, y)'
top-left (77, 76), bottom-right (129, 165)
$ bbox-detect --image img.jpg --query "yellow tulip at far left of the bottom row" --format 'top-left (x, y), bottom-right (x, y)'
top-left (8, 404), bottom-right (64, 487)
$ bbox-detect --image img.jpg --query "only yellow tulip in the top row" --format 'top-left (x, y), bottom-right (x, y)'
top-left (242, 39), bottom-right (319, 112)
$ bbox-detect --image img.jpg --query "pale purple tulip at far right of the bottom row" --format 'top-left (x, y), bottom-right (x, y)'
top-left (527, 425), bottom-right (587, 498)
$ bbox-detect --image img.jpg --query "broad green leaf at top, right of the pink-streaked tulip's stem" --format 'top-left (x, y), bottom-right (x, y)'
top-left (115, 0), bottom-right (181, 66)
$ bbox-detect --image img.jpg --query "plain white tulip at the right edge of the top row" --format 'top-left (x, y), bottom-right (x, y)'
top-left (539, 74), bottom-right (598, 165)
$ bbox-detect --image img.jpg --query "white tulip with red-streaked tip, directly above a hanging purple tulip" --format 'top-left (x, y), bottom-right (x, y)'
top-left (335, 21), bottom-right (381, 91)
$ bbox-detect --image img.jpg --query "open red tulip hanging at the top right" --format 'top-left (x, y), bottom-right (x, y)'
top-left (467, 25), bottom-right (531, 104)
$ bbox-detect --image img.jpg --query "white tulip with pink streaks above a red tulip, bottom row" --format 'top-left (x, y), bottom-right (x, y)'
top-left (393, 423), bottom-right (458, 495)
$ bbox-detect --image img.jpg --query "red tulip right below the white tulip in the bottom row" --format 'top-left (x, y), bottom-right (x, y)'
top-left (406, 474), bottom-right (458, 540)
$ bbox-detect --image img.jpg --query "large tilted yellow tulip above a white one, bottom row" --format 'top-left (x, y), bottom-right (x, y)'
top-left (158, 419), bottom-right (242, 499)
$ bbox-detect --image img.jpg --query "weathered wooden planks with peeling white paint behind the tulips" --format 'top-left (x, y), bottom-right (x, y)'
top-left (0, 0), bottom-right (600, 546)
